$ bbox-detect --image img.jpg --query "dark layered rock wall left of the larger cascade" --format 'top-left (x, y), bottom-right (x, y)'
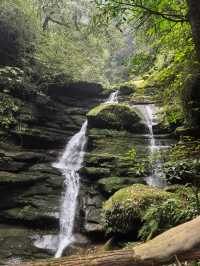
top-left (0, 82), bottom-right (102, 259)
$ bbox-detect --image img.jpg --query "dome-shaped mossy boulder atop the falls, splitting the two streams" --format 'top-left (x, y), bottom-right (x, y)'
top-left (87, 104), bottom-right (148, 133)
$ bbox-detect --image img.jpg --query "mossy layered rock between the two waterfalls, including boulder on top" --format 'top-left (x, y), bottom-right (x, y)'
top-left (77, 91), bottom-right (174, 239)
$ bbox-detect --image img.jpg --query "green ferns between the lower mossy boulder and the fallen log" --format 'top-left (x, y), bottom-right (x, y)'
top-left (139, 187), bottom-right (199, 240)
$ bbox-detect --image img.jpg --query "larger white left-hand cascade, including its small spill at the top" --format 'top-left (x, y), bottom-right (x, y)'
top-left (49, 91), bottom-right (118, 258)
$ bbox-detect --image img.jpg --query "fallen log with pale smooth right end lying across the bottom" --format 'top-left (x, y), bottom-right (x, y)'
top-left (21, 216), bottom-right (200, 266)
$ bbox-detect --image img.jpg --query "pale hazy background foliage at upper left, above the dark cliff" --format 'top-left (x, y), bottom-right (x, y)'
top-left (0, 0), bottom-right (130, 85)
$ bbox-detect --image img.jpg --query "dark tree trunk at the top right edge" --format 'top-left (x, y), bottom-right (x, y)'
top-left (187, 0), bottom-right (200, 61)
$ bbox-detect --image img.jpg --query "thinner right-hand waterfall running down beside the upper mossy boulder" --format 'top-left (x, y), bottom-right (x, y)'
top-left (135, 104), bottom-right (167, 187)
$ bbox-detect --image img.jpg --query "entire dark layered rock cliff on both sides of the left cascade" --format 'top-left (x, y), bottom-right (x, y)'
top-left (0, 82), bottom-right (175, 260)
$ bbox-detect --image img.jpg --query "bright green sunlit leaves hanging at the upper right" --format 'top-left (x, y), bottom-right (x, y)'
top-left (97, 0), bottom-right (196, 125)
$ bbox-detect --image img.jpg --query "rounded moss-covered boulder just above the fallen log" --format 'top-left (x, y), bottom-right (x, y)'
top-left (102, 184), bottom-right (173, 235)
